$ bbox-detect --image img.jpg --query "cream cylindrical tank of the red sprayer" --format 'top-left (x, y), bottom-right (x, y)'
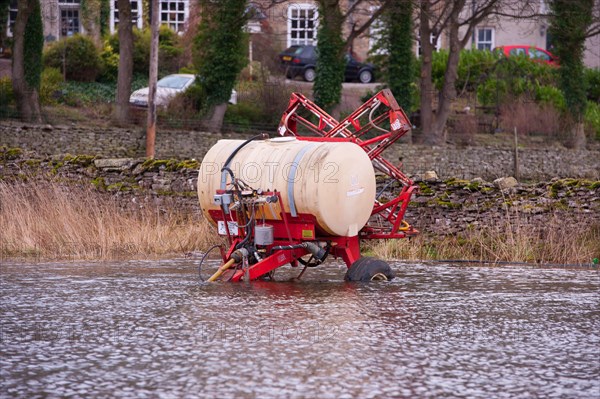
top-left (198, 137), bottom-right (376, 237)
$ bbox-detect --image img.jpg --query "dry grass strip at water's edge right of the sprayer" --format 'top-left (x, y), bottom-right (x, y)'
top-left (370, 214), bottom-right (600, 264)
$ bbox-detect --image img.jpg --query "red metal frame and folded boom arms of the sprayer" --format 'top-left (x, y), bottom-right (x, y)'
top-left (209, 89), bottom-right (418, 281)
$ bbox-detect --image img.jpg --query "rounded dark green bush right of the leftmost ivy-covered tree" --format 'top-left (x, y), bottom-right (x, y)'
top-left (44, 35), bottom-right (101, 82)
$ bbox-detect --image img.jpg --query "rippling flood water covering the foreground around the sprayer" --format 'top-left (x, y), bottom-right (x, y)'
top-left (0, 259), bottom-right (600, 398)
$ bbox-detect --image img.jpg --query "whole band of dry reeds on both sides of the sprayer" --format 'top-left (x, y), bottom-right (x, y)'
top-left (0, 182), bottom-right (600, 264)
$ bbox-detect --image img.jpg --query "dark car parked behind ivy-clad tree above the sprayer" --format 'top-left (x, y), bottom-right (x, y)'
top-left (279, 45), bottom-right (375, 83)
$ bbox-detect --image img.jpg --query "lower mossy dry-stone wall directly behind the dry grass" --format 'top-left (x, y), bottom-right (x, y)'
top-left (0, 148), bottom-right (600, 239)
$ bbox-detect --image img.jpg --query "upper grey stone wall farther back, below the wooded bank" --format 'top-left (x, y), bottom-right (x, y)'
top-left (0, 122), bottom-right (600, 181)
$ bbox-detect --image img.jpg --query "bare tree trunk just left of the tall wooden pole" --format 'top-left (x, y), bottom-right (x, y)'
top-left (114, 0), bottom-right (133, 124)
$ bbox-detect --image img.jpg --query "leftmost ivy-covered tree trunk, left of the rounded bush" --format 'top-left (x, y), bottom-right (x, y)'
top-left (12, 0), bottom-right (43, 123)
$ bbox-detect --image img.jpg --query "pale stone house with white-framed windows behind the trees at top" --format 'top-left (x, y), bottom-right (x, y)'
top-left (8, 0), bottom-right (600, 68)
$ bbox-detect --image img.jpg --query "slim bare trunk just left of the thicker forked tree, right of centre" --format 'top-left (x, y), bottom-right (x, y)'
top-left (419, 0), bottom-right (437, 145)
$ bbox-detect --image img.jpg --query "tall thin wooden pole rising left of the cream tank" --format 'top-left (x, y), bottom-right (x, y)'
top-left (146, 0), bottom-right (160, 159)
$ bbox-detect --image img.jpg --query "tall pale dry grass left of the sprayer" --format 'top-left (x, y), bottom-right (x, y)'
top-left (0, 183), bottom-right (217, 259)
